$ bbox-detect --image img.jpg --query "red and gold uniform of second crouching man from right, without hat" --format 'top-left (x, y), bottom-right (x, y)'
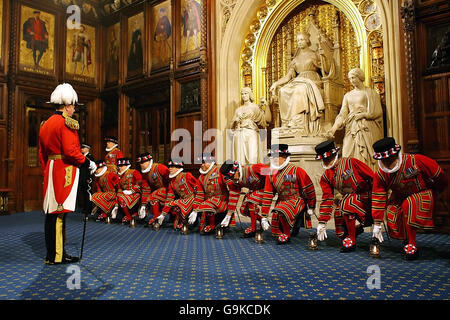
top-left (318, 158), bottom-right (373, 245)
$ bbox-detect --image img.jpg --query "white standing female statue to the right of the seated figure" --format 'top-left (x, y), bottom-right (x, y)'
top-left (327, 68), bottom-right (384, 169)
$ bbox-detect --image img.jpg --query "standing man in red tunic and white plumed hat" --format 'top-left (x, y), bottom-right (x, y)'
top-left (39, 83), bottom-right (95, 264)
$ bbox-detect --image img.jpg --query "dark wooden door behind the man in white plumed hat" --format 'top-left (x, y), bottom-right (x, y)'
top-left (23, 107), bottom-right (54, 211)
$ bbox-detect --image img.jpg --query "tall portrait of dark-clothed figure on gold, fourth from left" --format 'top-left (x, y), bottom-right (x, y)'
top-left (127, 12), bottom-right (144, 77)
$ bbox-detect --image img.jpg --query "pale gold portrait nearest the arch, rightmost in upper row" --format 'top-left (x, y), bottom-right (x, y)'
top-left (180, 0), bottom-right (202, 62)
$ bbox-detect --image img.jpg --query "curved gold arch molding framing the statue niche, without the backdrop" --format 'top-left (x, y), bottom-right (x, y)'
top-left (240, 0), bottom-right (384, 103)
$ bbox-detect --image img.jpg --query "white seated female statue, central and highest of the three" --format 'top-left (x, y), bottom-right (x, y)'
top-left (270, 32), bottom-right (328, 136)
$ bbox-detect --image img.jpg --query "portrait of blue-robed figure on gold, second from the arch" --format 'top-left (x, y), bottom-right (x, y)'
top-left (150, 0), bottom-right (172, 70)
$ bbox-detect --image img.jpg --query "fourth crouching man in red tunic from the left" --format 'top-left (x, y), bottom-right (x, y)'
top-left (157, 159), bottom-right (205, 230)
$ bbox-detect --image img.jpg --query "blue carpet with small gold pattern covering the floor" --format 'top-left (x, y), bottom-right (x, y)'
top-left (0, 212), bottom-right (450, 300)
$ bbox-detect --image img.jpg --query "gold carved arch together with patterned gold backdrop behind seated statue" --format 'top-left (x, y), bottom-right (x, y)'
top-left (240, 0), bottom-right (385, 130)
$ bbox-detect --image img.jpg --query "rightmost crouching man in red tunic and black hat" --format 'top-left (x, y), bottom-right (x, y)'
top-left (372, 137), bottom-right (447, 260)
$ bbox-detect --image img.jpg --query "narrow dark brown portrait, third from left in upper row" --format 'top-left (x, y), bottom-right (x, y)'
top-left (105, 22), bottom-right (120, 83)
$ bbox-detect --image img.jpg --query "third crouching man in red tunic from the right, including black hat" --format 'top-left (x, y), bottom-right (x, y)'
top-left (262, 144), bottom-right (316, 244)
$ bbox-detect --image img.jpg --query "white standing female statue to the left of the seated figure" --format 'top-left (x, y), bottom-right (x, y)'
top-left (231, 87), bottom-right (271, 164)
